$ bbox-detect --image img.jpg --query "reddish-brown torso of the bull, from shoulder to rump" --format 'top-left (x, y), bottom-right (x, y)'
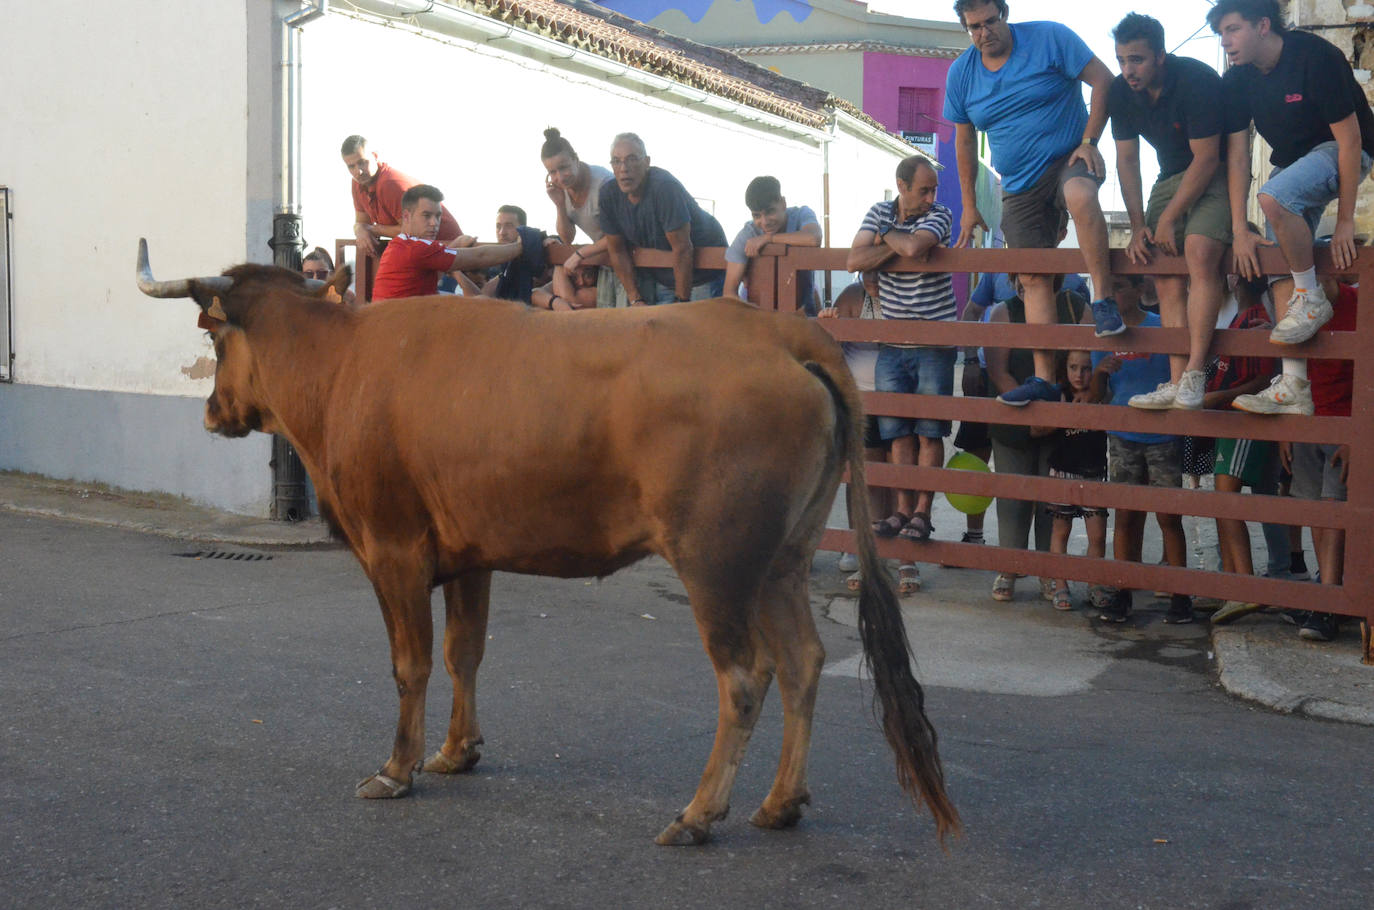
top-left (324, 298), bottom-right (848, 575)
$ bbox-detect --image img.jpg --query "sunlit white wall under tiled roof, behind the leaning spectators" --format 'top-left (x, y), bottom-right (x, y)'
top-left (302, 14), bottom-right (897, 263)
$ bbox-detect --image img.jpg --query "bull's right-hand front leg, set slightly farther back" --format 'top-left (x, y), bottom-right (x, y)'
top-left (425, 572), bottom-right (492, 774)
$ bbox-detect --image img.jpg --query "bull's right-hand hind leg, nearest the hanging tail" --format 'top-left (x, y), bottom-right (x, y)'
top-left (749, 551), bottom-right (826, 828)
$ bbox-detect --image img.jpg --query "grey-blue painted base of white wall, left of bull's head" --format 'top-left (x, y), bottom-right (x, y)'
top-left (0, 384), bottom-right (272, 517)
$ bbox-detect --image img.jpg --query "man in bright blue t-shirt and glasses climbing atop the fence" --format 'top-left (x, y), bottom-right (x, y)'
top-left (944, 0), bottom-right (1125, 406)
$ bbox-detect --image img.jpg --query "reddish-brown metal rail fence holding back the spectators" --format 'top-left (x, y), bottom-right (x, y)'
top-left (337, 241), bottom-right (1374, 664)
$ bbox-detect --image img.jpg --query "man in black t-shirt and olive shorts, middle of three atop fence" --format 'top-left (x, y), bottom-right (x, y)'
top-left (1107, 12), bottom-right (1231, 411)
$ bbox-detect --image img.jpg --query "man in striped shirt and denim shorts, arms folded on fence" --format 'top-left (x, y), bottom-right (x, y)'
top-left (845, 155), bottom-right (956, 549)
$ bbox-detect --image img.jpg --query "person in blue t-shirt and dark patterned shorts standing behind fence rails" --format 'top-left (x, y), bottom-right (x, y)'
top-left (1091, 275), bottom-right (1193, 623)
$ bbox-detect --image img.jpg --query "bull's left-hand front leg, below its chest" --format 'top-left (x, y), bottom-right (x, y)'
top-left (357, 562), bottom-right (434, 799)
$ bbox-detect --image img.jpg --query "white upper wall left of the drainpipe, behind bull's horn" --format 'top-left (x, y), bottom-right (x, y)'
top-left (0, 0), bottom-right (271, 396)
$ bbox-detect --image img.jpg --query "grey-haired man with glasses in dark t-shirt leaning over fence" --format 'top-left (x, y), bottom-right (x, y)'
top-left (600, 133), bottom-right (725, 307)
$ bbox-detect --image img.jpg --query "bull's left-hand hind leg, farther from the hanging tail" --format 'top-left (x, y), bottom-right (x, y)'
top-left (655, 572), bottom-right (772, 847)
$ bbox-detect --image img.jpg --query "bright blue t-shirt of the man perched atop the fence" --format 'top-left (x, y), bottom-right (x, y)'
top-left (944, 22), bottom-right (1092, 192)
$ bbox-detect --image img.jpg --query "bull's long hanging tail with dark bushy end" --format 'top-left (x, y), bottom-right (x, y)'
top-left (807, 363), bottom-right (959, 843)
